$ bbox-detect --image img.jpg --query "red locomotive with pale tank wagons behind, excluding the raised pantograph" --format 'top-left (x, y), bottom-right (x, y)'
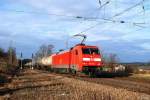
top-left (35, 44), bottom-right (103, 75)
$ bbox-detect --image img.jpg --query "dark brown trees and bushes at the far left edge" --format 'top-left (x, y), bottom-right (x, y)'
top-left (0, 47), bottom-right (19, 85)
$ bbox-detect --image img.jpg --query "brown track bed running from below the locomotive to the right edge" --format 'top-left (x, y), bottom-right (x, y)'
top-left (50, 73), bottom-right (150, 94)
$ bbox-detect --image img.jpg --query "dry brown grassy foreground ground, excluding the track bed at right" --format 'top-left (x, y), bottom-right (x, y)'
top-left (1, 71), bottom-right (150, 100)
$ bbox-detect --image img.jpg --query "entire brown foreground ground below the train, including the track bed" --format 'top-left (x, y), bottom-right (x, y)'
top-left (0, 69), bottom-right (150, 100)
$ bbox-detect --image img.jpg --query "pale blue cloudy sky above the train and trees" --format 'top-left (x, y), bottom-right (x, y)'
top-left (0, 0), bottom-right (150, 62)
